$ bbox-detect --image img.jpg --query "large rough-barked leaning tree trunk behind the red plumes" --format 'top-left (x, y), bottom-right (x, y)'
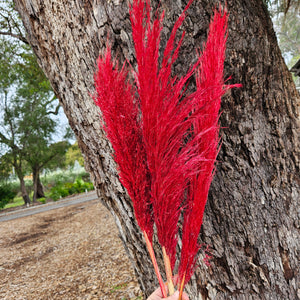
top-left (15, 0), bottom-right (300, 300)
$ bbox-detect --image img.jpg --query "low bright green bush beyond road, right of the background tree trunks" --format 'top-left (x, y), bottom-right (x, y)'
top-left (49, 177), bottom-right (94, 201)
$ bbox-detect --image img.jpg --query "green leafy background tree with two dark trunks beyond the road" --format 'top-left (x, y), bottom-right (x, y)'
top-left (0, 39), bottom-right (67, 203)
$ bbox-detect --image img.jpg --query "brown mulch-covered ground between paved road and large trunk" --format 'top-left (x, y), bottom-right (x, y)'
top-left (0, 200), bottom-right (143, 300)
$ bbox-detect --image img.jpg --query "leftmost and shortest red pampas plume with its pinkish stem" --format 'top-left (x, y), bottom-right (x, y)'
top-left (94, 47), bottom-right (167, 297)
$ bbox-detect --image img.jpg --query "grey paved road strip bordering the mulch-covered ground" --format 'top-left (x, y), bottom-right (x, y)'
top-left (0, 191), bottom-right (98, 222)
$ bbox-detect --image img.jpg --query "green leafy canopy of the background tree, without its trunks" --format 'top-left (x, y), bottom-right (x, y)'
top-left (0, 38), bottom-right (55, 196)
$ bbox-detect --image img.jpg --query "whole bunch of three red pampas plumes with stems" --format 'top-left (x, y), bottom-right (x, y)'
top-left (94, 0), bottom-right (239, 299)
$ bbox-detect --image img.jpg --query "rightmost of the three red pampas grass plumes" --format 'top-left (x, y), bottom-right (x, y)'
top-left (179, 8), bottom-right (239, 294)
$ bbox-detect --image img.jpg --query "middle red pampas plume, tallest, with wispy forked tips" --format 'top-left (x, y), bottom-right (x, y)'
top-left (130, 0), bottom-right (197, 294)
